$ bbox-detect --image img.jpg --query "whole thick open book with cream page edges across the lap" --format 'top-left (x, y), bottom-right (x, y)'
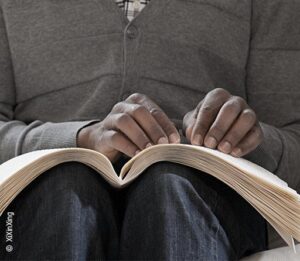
top-left (0, 144), bottom-right (300, 246)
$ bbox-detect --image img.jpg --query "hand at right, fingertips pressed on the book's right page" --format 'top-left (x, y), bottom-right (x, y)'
top-left (183, 89), bottom-right (263, 157)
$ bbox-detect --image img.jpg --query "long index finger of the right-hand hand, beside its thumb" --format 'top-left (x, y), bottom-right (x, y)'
top-left (192, 89), bottom-right (230, 145)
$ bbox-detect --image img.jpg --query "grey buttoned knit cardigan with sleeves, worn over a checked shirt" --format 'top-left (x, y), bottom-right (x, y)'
top-left (0, 0), bottom-right (300, 188)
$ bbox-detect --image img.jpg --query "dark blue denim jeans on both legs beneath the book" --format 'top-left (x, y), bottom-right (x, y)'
top-left (0, 159), bottom-right (266, 261)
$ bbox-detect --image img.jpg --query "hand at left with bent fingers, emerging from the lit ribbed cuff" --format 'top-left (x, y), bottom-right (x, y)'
top-left (77, 93), bottom-right (180, 162)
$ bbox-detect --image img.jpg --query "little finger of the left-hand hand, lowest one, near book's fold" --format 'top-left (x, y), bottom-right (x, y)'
top-left (103, 130), bottom-right (140, 157)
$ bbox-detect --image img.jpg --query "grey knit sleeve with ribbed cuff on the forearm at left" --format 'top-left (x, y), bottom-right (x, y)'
top-left (0, 117), bottom-right (96, 164)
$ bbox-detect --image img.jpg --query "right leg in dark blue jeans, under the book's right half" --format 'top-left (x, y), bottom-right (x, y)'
top-left (121, 162), bottom-right (266, 260)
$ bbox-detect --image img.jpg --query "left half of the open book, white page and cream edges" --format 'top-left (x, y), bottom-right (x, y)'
top-left (0, 148), bottom-right (120, 215)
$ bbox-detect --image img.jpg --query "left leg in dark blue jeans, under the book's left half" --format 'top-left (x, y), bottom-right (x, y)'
top-left (0, 163), bottom-right (118, 260)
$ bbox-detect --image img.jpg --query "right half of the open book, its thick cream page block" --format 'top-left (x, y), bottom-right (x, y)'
top-left (121, 144), bottom-right (300, 245)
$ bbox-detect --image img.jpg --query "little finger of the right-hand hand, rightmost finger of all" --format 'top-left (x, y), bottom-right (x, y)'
top-left (231, 124), bottom-right (263, 158)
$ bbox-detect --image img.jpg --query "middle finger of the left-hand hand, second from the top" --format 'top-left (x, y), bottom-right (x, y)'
top-left (125, 103), bottom-right (169, 144)
